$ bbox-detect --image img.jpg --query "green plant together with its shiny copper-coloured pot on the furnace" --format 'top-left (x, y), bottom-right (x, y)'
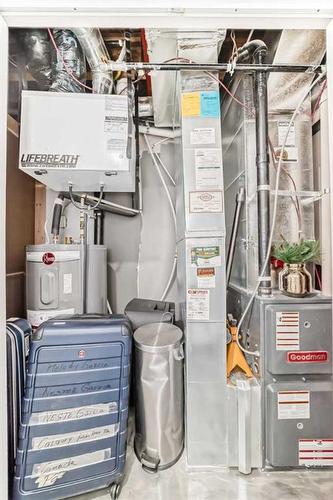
top-left (272, 240), bottom-right (320, 297)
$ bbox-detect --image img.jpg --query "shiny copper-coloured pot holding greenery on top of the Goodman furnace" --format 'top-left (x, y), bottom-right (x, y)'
top-left (279, 263), bottom-right (312, 298)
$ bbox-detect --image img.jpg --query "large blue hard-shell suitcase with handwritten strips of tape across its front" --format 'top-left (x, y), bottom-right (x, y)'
top-left (13, 315), bottom-right (132, 500)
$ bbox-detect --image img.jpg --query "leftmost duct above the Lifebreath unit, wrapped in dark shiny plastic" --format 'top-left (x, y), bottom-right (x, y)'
top-left (19, 29), bottom-right (52, 90)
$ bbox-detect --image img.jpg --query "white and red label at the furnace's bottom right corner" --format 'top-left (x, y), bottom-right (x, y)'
top-left (298, 439), bottom-right (333, 467)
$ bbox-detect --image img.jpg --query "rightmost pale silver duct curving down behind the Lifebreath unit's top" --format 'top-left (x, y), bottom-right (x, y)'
top-left (72, 28), bottom-right (113, 94)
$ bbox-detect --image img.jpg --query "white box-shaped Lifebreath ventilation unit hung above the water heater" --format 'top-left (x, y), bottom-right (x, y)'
top-left (20, 91), bottom-right (135, 192)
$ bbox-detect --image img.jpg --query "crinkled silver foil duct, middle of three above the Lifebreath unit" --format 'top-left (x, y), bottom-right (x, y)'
top-left (49, 29), bottom-right (86, 92)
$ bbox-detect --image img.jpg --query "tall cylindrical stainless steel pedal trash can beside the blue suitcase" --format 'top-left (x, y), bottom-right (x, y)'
top-left (134, 323), bottom-right (184, 472)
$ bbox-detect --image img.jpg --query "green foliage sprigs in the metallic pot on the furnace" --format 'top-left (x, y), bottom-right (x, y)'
top-left (272, 240), bottom-right (320, 264)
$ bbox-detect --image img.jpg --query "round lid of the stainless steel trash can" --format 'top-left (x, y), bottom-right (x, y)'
top-left (134, 323), bottom-right (183, 352)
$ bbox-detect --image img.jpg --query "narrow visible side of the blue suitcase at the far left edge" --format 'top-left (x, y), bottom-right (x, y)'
top-left (6, 318), bottom-right (31, 496)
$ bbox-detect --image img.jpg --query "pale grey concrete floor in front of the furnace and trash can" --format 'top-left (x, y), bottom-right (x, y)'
top-left (76, 447), bottom-right (333, 500)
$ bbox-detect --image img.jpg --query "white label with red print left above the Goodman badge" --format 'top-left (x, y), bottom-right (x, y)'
top-left (275, 311), bottom-right (300, 351)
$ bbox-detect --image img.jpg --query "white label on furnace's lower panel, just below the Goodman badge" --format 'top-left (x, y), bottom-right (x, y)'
top-left (278, 391), bottom-right (310, 420)
